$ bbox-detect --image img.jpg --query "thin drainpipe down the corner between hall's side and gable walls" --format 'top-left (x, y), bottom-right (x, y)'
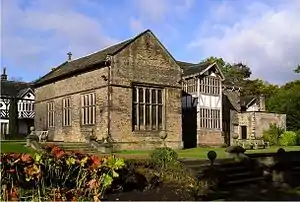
top-left (106, 55), bottom-right (112, 139)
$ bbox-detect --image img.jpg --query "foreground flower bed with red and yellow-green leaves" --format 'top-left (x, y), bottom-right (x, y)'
top-left (0, 145), bottom-right (219, 201)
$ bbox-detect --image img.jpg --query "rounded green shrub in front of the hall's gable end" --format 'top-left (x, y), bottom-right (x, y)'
top-left (150, 147), bottom-right (178, 169)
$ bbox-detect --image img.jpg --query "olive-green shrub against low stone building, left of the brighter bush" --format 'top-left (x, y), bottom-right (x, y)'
top-left (262, 124), bottom-right (285, 145)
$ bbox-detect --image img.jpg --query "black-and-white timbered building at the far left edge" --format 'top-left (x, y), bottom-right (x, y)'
top-left (0, 68), bottom-right (35, 137)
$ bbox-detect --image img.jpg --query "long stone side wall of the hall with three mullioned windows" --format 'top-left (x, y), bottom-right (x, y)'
top-left (35, 68), bottom-right (107, 142)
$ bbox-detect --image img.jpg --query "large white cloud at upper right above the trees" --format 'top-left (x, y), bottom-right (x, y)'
top-left (189, 1), bottom-right (300, 84)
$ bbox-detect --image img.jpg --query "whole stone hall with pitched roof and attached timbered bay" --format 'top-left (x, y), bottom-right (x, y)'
top-left (35, 30), bottom-right (286, 149)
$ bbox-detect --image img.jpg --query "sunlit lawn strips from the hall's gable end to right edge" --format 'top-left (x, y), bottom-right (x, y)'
top-left (116, 146), bottom-right (300, 159)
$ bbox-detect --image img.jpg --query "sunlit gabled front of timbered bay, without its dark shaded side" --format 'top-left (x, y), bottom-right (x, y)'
top-left (178, 62), bottom-right (224, 145)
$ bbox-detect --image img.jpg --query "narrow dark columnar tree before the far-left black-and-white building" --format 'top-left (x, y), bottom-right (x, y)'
top-left (9, 97), bottom-right (19, 137)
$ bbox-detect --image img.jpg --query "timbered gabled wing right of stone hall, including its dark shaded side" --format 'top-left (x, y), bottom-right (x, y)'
top-left (178, 61), bottom-right (225, 147)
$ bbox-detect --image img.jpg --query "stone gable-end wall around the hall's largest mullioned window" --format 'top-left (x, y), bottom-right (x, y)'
top-left (111, 30), bottom-right (182, 149)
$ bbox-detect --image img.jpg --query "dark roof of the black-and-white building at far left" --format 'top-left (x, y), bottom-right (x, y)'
top-left (1, 80), bottom-right (32, 97)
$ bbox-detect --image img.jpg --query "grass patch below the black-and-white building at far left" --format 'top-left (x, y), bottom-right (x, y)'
top-left (1, 141), bottom-right (34, 154)
